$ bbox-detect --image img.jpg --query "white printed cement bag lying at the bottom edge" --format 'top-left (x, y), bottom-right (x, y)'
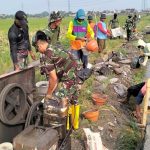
top-left (83, 128), bottom-right (108, 150)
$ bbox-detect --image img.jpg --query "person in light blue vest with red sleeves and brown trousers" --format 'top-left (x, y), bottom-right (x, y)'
top-left (97, 13), bottom-right (111, 53)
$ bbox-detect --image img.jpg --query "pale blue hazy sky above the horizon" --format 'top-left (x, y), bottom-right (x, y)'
top-left (0, 0), bottom-right (150, 14)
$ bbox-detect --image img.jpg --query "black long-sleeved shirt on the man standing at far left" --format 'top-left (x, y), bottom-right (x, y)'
top-left (8, 23), bottom-right (31, 64)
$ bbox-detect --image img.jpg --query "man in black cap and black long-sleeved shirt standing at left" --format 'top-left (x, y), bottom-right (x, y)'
top-left (8, 11), bottom-right (36, 71)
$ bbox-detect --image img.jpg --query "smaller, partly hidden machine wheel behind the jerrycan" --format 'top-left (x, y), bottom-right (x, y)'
top-left (25, 101), bottom-right (43, 128)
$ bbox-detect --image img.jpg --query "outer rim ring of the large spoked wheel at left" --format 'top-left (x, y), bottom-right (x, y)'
top-left (0, 83), bottom-right (27, 125)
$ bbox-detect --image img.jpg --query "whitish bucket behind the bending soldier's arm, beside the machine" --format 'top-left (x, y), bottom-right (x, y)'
top-left (36, 81), bottom-right (49, 96)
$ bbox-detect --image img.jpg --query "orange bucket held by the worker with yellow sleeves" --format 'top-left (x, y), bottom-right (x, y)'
top-left (86, 40), bottom-right (98, 52)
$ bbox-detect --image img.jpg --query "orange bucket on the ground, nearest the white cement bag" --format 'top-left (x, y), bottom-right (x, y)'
top-left (82, 109), bottom-right (99, 122)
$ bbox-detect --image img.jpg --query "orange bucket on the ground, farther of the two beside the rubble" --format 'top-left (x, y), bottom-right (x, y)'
top-left (92, 93), bottom-right (108, 106)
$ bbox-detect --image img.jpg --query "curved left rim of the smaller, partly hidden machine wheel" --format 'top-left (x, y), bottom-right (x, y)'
top-left (25, 101), bottom-right (43, 128)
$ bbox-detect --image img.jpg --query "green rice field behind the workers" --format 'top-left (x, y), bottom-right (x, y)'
top-left (0, 16), bottom-right (150, 74)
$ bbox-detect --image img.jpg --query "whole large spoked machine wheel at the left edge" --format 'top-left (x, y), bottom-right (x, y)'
top-left (0, 83), bottom-right (28, 125)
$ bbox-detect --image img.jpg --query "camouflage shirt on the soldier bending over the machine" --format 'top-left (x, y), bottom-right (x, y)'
top-left (41, 46), bottom-right (78, 81)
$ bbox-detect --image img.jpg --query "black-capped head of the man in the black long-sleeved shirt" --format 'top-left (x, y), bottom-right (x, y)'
top-left (15, 10), bottom-right (28, 25)
